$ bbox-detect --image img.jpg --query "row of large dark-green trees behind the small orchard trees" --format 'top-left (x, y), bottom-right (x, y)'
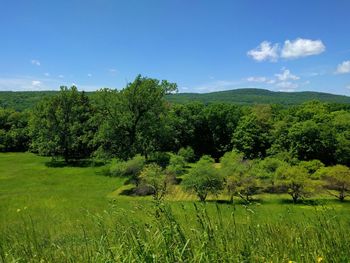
top-left (0, 76), bottom-right (350, 166)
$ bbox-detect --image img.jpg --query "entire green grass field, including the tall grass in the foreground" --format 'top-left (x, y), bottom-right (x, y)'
top-left (0, 153), bottom-right (350, 262)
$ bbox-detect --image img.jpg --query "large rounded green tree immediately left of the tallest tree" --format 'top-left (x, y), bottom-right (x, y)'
top-left (31, 86), bottom-right (94, 162)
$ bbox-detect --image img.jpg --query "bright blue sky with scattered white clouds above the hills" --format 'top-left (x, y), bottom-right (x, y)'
top-left (0, 0), bottom-right (350, 96)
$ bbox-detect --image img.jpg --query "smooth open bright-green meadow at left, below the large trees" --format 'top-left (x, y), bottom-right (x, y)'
top-left (0, 153), bottom-right (127, 232)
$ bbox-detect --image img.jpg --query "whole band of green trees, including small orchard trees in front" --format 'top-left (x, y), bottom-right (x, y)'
top-left (0, 76), bottom-right (350, 201)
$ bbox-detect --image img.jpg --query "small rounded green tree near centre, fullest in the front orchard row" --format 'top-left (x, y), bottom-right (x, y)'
top-left (182, 156), bottom-right (224, 202)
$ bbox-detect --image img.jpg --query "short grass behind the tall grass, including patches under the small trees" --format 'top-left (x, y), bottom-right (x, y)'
top-left (0, 153), bottom-right (350, 226)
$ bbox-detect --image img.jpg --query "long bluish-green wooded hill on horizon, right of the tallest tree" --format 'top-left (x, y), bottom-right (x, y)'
top-left (167, 89), bottom-right (350, 105)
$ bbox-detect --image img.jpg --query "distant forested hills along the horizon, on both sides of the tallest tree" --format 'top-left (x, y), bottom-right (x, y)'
top-left (0, 89), bottom-right (350, 110)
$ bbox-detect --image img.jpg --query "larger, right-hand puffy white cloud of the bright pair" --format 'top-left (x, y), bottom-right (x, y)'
top-left (281, 38), bottom-right (326, 59)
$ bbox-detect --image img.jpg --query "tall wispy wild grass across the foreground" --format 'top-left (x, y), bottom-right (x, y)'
top-left (0, 203), bottom-right (350, 262)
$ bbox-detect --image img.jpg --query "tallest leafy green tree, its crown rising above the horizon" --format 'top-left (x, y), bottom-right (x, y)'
top-left (95, 75), bottom-right (177, 159)
